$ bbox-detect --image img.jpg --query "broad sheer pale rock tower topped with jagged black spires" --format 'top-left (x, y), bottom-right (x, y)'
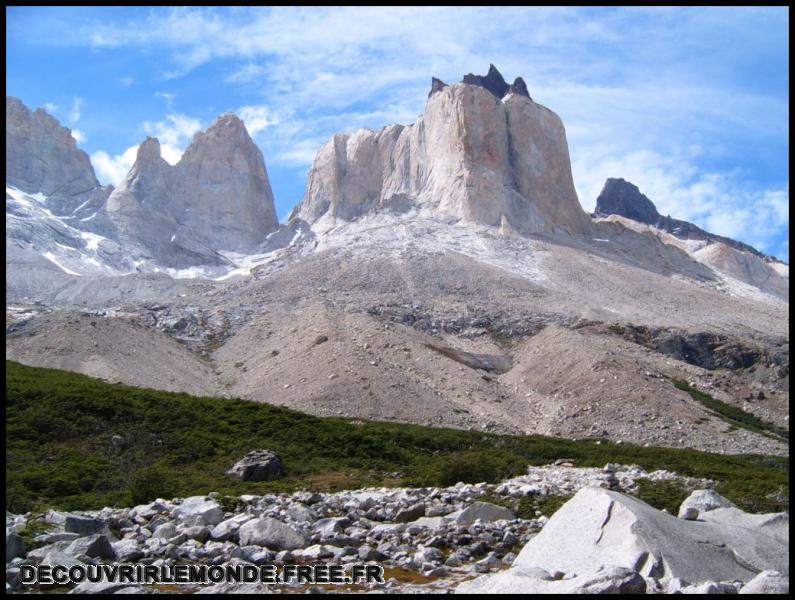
top-left (294, 66), bottom-right (591, 235)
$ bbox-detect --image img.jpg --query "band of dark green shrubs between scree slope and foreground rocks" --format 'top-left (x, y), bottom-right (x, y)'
top-left (6, 362), bottom-right (789, 514)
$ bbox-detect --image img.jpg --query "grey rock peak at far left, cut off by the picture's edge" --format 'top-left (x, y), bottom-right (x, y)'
top-left (6, 96), bottom-right (111, 217)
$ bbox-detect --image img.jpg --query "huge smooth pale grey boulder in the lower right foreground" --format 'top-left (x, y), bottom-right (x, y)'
top-left (457, 487), bottom-right (789, 593)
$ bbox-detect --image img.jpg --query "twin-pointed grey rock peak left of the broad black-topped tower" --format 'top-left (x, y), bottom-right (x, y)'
top-left (107, 114), bottom-right (278, 268)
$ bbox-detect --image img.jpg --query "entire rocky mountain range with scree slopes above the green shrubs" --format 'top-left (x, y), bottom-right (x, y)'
top-left (6, 65), bottom-right (789, 453)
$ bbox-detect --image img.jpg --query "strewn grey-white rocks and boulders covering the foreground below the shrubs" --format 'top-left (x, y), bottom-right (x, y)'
top-left (6, 463), bottom-right (764, 592)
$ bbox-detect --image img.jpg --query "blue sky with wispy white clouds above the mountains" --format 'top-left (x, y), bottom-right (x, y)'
top-left (6, 7), bottom-right (789, 261)
